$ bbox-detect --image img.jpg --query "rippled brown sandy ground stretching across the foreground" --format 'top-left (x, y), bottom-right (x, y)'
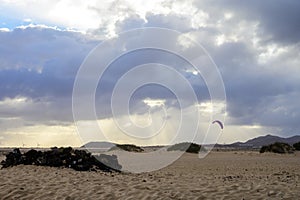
top-left (0, 152), bottom-right (300, 199)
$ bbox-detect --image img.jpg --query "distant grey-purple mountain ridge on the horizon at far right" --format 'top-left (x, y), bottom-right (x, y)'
top-left (228, 135), bottom-right (300, 147)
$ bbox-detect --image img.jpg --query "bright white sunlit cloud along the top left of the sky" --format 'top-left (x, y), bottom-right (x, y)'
top-left (0, 0), bottom-right (199, 37)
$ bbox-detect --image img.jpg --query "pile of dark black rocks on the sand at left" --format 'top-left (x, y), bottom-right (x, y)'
top-left (1, 147), bottom-right (122, 172)
